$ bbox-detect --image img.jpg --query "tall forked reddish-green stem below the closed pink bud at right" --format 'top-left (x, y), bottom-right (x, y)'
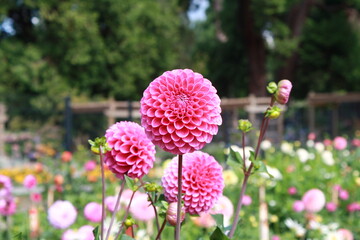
top-left (228, 97), bottom-right (275, 238)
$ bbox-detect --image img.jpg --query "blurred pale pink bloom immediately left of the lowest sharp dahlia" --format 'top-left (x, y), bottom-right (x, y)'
top-left (130, 193), bottom-right (155, 221)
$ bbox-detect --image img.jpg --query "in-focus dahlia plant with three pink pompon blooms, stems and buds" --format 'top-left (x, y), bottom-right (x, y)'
top-left (89, 69), bottom-right (292, 240)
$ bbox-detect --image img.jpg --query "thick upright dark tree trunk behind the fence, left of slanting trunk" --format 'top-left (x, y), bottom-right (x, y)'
top-left (239, 0), bottom-right (266, 96)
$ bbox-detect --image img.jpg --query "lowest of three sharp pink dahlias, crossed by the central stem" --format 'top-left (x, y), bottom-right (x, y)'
top-left (161, 151), bottom-right (224, 214)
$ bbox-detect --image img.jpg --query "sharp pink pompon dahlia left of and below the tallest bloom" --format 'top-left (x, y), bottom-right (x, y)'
top-left (104, 121), bottom-right (155, 179)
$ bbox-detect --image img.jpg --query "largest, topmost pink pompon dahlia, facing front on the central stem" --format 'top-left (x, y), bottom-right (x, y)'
top-left (140, 69), bottom-right (222, 154)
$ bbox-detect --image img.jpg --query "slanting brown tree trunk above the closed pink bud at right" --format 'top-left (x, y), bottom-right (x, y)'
top-left (279, 0), bottom-right (316, 80)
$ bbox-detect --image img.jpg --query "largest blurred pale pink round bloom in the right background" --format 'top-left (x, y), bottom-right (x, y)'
top-left (302, 188), bottom-right (325, 213)
